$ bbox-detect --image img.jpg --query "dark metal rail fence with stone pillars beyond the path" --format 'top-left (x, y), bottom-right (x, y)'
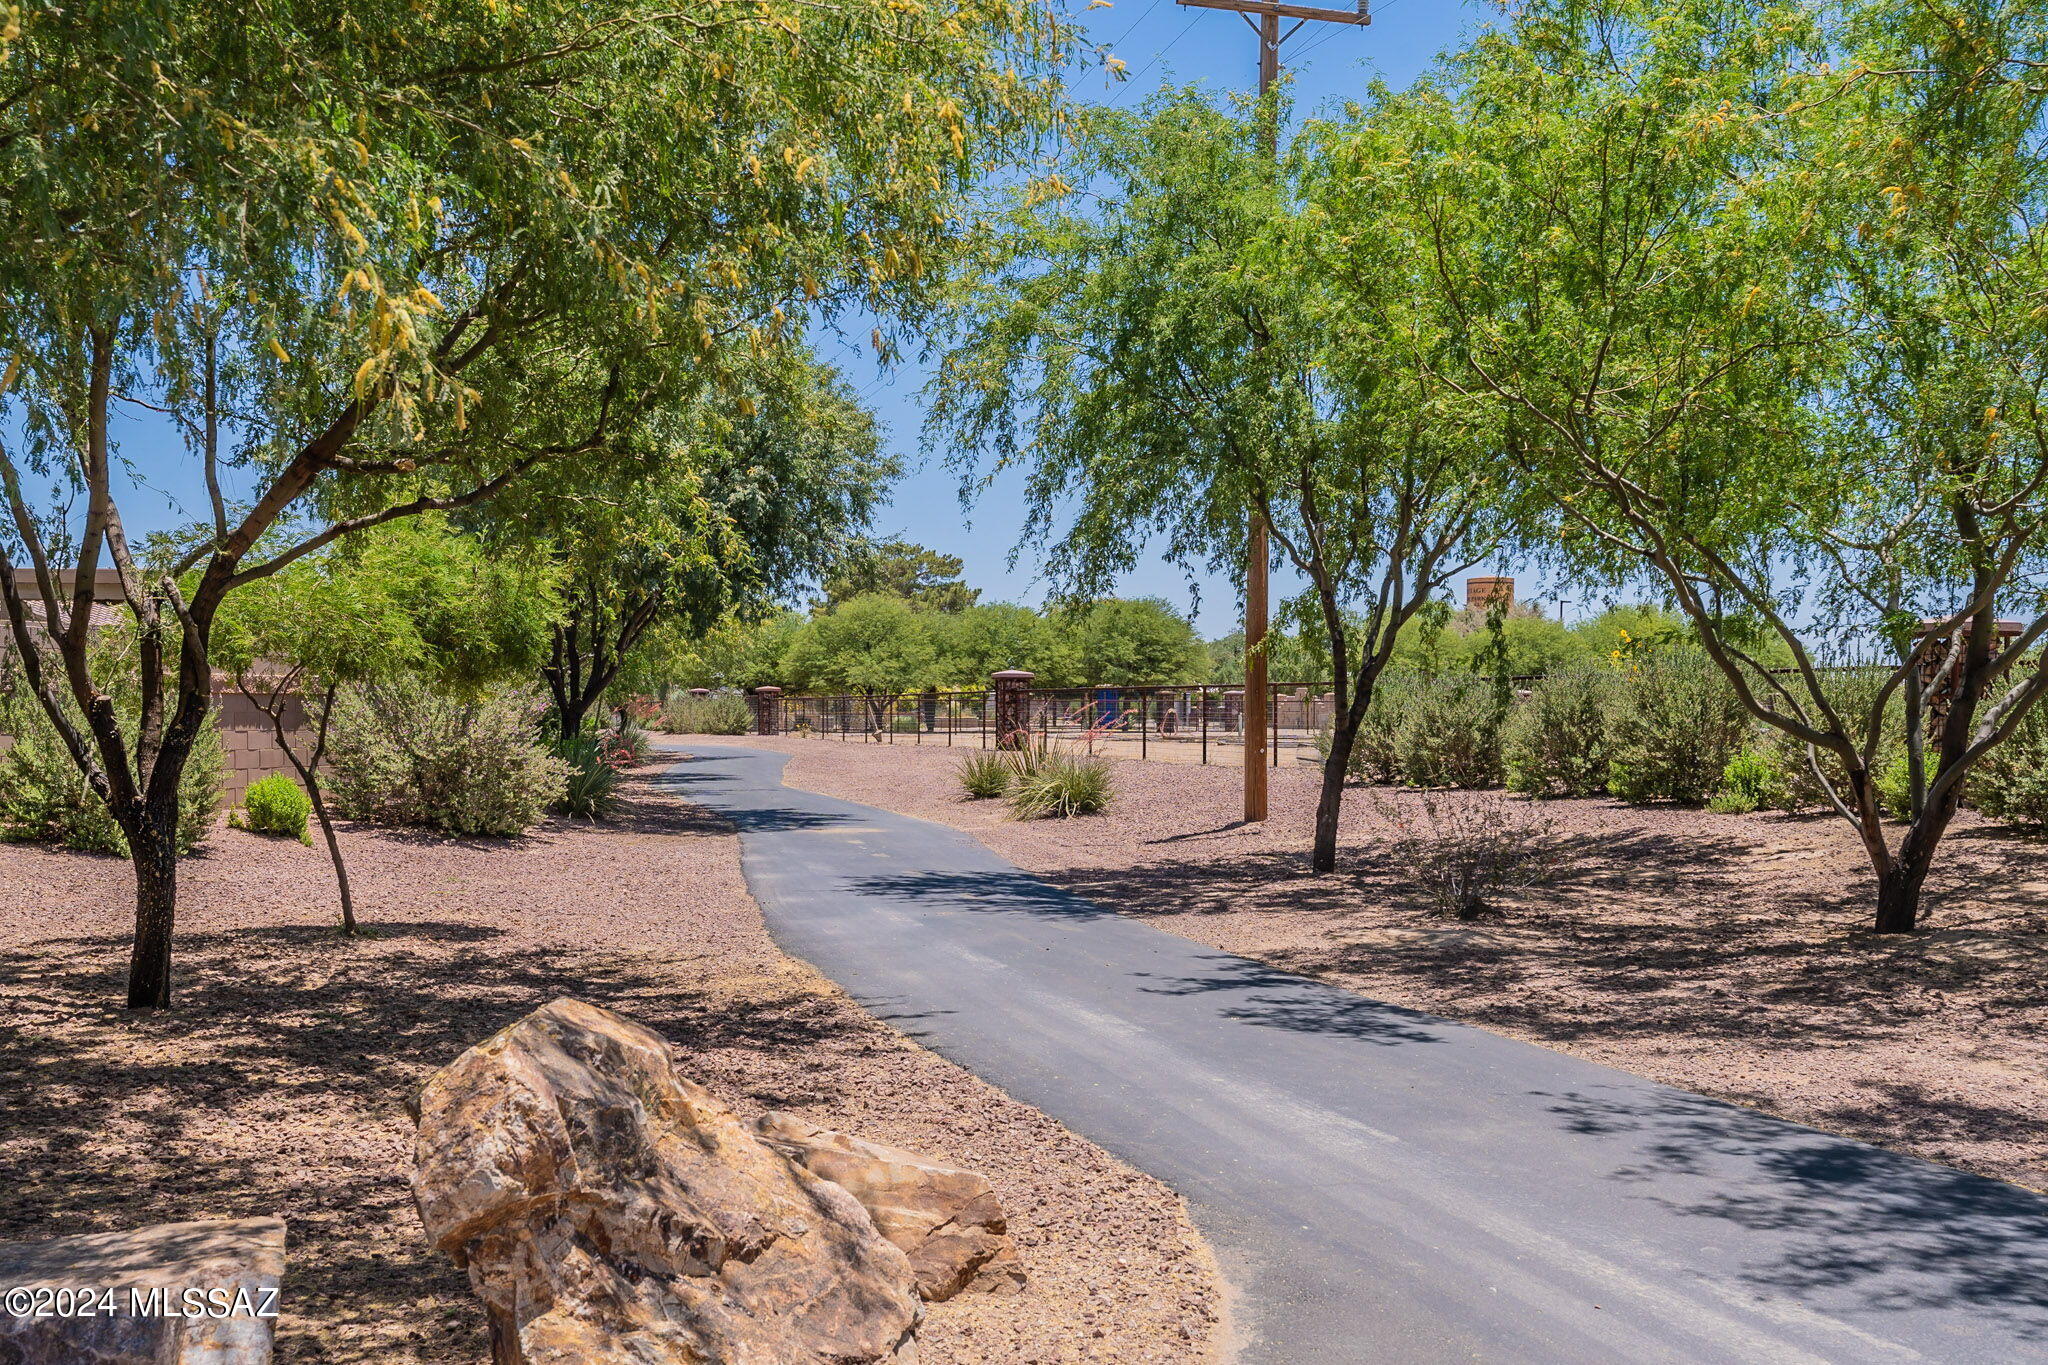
top-left (758, 684), bottom-right (1335, 767)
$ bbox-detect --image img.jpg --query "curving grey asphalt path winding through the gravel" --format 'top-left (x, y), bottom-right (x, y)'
top-left (672, 745), bottom-right (2048, 1365)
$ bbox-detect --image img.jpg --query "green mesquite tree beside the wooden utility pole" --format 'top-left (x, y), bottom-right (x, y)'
top-left (930, 92), bottom-right (1507, 872)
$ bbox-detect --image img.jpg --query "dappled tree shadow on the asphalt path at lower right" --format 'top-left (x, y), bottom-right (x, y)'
top-left (1546, 1091), bottom-right (2048, 1342)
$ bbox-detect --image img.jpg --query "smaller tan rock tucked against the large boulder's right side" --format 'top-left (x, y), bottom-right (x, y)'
top-left (754, 1113), bottom-right (1024, 1304)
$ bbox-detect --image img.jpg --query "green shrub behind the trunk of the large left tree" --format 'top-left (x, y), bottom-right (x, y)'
top-left (0, 690), bottom-right (225, 857)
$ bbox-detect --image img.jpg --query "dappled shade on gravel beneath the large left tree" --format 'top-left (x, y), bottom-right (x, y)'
top-left (0, 919), bottom-right (870, 1363)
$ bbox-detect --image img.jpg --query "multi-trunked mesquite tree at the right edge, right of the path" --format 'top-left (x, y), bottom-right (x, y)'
top-left (1401, 0), bottom-right (2048, 933)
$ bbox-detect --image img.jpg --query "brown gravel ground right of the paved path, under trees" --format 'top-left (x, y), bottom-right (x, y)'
top-left (692, 737), bottom-right (2048, 1189)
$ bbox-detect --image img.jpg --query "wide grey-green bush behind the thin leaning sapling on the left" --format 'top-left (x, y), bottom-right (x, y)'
top-left (328, 679), bottom-right (567, 835)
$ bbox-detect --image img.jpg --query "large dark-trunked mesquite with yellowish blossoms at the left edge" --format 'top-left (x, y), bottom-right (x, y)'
top-left (0, 0), bottom-right (1069, 1007)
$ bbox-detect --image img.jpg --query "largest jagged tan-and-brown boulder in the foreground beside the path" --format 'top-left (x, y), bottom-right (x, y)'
top-left (414, 1001), bottom-right (924, 1365)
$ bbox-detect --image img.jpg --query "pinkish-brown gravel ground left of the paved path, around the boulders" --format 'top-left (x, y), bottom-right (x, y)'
top-left (0, 772), bottom-right (1221, 1365)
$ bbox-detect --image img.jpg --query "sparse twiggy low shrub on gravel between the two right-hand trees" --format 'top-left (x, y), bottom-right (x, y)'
top-left (1376, 792), bottom-right (1561, 919)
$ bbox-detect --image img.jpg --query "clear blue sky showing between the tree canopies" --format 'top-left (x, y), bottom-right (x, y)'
top-left (103, 0), bottom-right (1579, 636)
